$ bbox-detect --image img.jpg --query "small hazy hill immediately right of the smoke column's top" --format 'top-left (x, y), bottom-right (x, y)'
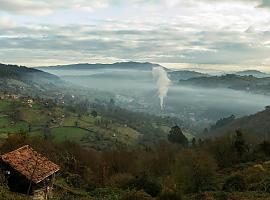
top-left (168, 70), bottom-right (209, 82)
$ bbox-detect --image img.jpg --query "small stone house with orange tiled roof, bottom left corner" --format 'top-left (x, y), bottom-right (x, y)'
top-left (1, 145), bottom-right (60, 200)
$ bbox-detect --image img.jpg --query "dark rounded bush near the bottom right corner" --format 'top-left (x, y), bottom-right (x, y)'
top-left (223, 174), bottom-right (246, 192)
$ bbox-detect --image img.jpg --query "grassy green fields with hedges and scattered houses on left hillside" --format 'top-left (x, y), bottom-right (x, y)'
top-left (0, 99), bottom-right (146, 148)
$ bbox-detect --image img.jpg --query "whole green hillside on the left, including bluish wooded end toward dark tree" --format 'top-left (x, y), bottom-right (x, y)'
top-left (0, 93), bottom-right (176, 149)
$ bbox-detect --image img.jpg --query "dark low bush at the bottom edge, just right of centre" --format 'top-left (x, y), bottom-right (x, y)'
top-left (128, 177), bottom-right (162, 197)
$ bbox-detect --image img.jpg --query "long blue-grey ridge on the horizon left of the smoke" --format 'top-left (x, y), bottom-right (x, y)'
top-left (38, 62), bottom-right (165, 70)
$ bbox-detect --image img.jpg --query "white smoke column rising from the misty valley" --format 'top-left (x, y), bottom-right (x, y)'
top-left (152, 67), bottom-right (171, 110)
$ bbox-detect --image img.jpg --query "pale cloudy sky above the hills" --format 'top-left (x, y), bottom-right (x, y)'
top-left (0, 0), bottom-right (270, 71)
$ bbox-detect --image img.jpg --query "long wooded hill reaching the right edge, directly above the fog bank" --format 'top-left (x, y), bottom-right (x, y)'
top-left (179, 74), bottom-right (270, 94)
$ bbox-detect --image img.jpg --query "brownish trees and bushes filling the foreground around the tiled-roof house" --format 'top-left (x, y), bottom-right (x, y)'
top-left (0, 125), bottom-right (270, 200)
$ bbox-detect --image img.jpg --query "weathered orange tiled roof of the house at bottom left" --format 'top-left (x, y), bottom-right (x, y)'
top-left (1, 145), bottom-right (60, 183)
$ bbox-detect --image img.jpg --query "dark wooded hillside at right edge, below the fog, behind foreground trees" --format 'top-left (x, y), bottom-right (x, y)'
top-left (207, 107), bottom-right (270, 138)
